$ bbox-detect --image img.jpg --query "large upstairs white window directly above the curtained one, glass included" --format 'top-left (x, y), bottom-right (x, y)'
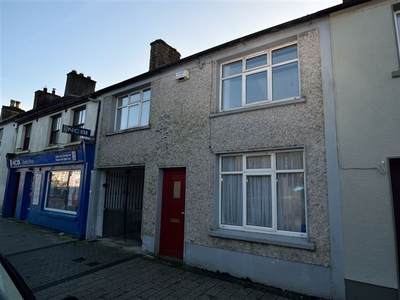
top-left (220, 44), bottom-right (300, 111)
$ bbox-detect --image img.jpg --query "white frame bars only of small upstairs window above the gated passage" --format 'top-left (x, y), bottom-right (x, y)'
top-left (114, 87), bottom-right (151, 131)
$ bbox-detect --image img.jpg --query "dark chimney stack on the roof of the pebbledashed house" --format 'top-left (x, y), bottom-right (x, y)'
top-left (149, 39), bottom-right (181, 71)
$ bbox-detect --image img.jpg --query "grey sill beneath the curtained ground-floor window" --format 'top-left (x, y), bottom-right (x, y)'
top-left (208, 229), bottom-right (315, 251)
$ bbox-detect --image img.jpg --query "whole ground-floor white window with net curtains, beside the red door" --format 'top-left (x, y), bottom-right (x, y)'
top-left (219, 150), bottom-right (307, 237)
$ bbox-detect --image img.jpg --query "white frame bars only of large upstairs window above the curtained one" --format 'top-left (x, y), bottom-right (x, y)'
top-left (219, 41), bottom-right (301, 111)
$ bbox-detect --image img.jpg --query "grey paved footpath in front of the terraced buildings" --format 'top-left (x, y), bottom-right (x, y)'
top-left (0, 218), bottom-right (315, 300)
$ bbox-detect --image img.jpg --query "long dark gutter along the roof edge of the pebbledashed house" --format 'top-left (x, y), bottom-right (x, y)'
top-left (92, 0), bottom-right (373, 98)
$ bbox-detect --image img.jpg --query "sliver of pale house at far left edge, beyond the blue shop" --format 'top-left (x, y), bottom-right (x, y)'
top-left (0, 100), bottom-right (24, 214)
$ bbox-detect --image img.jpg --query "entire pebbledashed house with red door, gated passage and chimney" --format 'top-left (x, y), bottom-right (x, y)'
top-left (87, 3), bottom-right (346, 298)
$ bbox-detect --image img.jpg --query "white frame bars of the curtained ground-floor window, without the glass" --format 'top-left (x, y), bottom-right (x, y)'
top-left (218, 149), bottom-right (308, 238)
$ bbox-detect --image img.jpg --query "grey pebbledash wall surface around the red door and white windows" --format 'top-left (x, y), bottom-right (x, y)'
top-left (97, 20), bottom-right (331, 297)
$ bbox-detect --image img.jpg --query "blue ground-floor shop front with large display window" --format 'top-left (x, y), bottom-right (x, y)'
top-left (3, 141), bottom-right (94, 239)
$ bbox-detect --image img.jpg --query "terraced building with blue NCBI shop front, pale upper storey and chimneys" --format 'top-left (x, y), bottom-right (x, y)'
top-left (3, 71), bottom-right (99, 238)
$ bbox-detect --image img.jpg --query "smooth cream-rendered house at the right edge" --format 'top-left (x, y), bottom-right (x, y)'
top-left (331, 0), bottom-right (400, 299)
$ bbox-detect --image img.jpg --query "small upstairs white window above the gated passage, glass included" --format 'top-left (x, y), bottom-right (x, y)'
top-left (115, 89), bottom-right (151, 130)
